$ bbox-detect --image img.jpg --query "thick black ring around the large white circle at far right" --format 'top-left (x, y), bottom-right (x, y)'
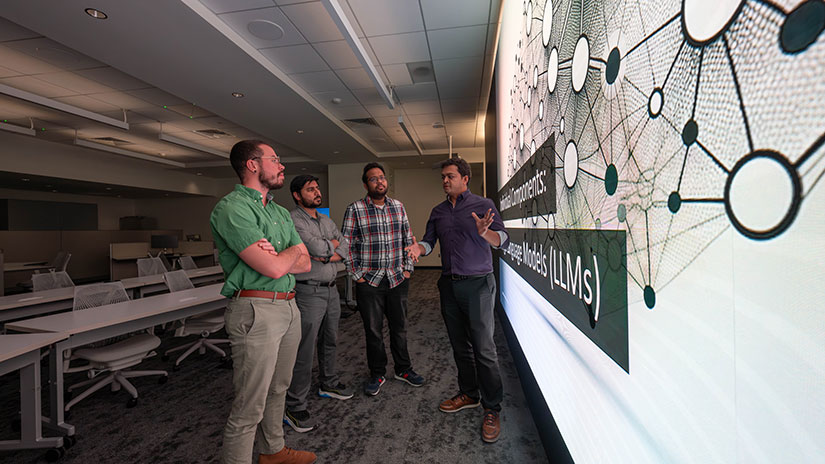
top-left (724, 150), bottom-right (802, 240)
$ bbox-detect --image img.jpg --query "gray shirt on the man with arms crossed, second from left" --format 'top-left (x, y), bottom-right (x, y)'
top-left (289, 206), bottom-right (349, 282)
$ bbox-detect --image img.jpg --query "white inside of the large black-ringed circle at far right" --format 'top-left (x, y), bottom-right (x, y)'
top-left (730, 157), bottom-right (794, 232)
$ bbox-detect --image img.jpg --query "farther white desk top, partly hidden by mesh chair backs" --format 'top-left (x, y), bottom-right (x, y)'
top-left (0, 266), bottom-right (223, 324)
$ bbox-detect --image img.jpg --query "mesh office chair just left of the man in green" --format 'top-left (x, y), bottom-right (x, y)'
top-left (163, 270), bottom-right (229, 369)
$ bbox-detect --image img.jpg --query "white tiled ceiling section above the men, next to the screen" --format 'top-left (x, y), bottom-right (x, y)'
top-left (201, 0), bottom-right (500, 154)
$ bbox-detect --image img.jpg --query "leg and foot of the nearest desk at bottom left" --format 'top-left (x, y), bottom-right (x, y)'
top-left (0, 350), bottom-right (63, 451)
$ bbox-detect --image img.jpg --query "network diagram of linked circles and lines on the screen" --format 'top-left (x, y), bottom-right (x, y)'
top-left (503, 0), bottom-right (825, 309)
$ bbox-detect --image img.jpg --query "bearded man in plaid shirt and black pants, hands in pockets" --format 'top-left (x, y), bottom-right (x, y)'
top-left (341, 163), bottom-right (424, 396)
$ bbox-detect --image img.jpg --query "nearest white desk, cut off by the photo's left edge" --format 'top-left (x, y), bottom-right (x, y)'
top-left (0, 333), bottom-right (68, 451)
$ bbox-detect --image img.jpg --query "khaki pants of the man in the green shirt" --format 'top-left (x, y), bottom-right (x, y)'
top-left (221, 298), bottom-right (301, 464)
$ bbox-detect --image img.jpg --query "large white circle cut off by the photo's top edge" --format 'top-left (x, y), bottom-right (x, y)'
top-left (682, 0), bottom-right (745, 45)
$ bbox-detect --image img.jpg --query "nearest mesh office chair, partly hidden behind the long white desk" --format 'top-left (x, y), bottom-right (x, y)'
top-left (65, 282), bottom-right (169, 411)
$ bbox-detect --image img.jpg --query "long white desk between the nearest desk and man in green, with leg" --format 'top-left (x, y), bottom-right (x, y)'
top-left (6, 284), bottom-right (227, 435)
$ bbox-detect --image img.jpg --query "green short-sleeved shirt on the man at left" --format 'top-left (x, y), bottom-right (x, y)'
top-left (209, 185), bottom-right (302, 297)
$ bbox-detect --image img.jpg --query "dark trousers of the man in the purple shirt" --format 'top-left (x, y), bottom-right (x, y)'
top-left (438, 274), bottom-right (504, 411)
